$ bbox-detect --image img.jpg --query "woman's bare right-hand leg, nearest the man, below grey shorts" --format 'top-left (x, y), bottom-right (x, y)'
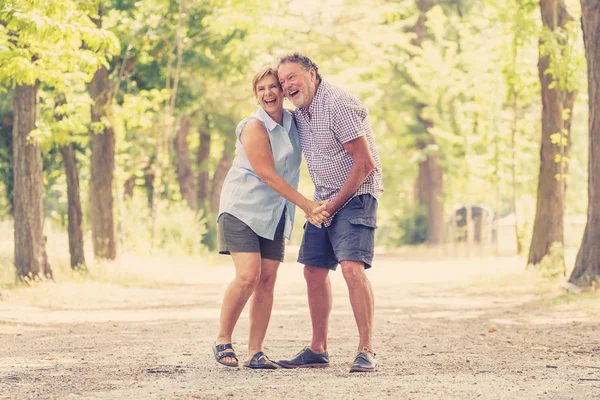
top-left (248, 258), bottom-right (280, 358)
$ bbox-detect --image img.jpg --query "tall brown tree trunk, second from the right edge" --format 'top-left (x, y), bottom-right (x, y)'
top-left (527, 0), bottom-right (577, 265)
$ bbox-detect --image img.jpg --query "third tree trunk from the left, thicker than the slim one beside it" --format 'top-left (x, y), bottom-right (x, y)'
top-left (88, 63), bottom-right (117, 260)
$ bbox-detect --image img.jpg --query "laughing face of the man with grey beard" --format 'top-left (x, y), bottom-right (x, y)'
top-left (277, 62), bottom-right (317, 110)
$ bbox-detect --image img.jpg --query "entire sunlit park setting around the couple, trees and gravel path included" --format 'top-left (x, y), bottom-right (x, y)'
top-left (0, 0), bottom-right (600, 398)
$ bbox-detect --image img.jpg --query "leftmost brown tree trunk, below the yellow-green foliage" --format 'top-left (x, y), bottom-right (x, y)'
top-left (13, 85), bottom-right (52, 279)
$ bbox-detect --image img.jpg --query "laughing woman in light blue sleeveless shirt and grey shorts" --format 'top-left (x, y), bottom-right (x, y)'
top-left (213, 67), bottom-right (327, 369)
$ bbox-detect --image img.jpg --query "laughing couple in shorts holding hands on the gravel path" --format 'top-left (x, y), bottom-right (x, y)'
top-left (213, 53), bottom-right (383, 372)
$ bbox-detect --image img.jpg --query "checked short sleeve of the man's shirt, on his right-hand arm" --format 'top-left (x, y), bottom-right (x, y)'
top-left (330, 95), bottom-right (369, 144)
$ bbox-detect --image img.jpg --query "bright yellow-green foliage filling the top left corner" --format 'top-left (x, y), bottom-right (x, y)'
top-left (0, 0), bottom-right (119, 89)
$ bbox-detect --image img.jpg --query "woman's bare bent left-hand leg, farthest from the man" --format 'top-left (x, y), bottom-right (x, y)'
top-left (216, 253), bottom-right (261, 363)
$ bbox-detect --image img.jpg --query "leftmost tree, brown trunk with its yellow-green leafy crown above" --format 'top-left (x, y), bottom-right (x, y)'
top-left (0, 0), bottom-right (116, 278)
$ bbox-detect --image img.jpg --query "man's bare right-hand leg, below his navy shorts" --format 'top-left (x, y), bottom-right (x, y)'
top-left (340, 261), bottom-right (375, 353)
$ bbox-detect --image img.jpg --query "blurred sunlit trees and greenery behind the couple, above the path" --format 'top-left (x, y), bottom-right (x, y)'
top-left (0, 0), bottom-right (588, 286)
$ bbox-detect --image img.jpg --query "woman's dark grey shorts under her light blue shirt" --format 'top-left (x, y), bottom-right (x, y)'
top-left (218, 210), bottom-right (285, 261)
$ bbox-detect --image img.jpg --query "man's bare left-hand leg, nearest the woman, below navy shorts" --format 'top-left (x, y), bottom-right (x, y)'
top-left (304, 265), bottom-right (333, 354)
